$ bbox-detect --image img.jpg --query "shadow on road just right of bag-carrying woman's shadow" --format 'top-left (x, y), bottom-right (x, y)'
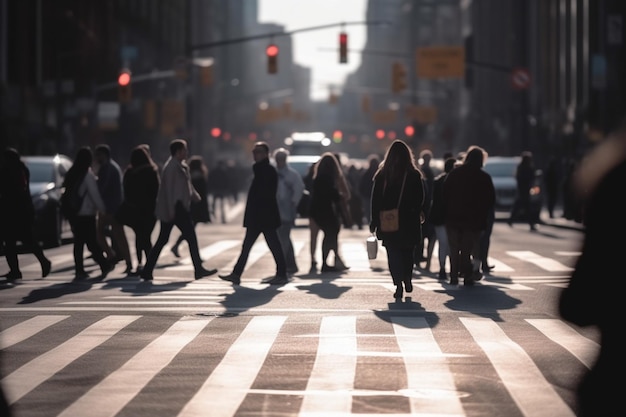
top-left (436, 282), bottom-right (522, 321)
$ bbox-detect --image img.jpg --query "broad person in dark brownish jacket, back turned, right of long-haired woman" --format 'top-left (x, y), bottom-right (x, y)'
top-left (443, 146), bottom-right (496, 285)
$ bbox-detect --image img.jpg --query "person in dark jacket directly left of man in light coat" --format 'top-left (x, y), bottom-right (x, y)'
top-left (119, 146), bottom-right (160, 275)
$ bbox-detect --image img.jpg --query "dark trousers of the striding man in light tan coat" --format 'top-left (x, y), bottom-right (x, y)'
top-left (143, 203), bottom-right (203, 275)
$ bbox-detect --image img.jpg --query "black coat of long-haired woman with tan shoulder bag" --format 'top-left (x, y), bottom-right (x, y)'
top-left (370, 170), bottom-right (424, 247)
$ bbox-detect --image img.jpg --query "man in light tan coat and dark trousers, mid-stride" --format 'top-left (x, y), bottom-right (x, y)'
top-left (140, 139), bottom-right (217, 281)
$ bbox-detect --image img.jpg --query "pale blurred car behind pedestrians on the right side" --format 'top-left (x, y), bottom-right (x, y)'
top-left (483, 156), bottom-right (543, 220)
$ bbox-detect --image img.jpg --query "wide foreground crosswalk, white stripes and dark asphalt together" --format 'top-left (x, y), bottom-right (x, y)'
top-left (0, 312), bottom-right (599, 417)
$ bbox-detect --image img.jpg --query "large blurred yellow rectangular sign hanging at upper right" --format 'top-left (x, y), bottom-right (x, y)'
top-left (415, 46), bottom-right (465, 79)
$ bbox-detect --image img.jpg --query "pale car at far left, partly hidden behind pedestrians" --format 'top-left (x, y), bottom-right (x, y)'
top-left (22, 154), bottom-right (72, 247)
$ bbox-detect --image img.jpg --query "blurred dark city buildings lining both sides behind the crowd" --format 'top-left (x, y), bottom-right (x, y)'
top-left (0, 0), bottom-right (626, 164)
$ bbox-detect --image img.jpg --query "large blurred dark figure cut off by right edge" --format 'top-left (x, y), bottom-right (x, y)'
top-left (559, 131), bottom-right (626, 417)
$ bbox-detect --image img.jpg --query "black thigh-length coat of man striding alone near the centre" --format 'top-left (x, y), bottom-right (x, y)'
top-left (243, 159), bottom-right (280, 230)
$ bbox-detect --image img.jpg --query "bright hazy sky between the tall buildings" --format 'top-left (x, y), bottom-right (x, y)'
top-left (259, 0), bottom-right (367, 100)
